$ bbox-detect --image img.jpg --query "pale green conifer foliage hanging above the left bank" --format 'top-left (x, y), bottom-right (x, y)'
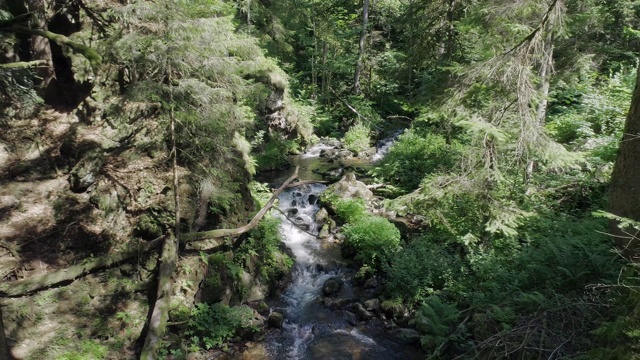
top-left (107, 0), bottom-right (288, 190)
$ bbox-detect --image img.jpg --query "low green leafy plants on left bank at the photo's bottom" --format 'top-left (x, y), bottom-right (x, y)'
top-left (185, 303), bottom-right (253, 350)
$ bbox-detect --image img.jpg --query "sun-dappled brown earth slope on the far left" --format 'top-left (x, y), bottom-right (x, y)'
top-left (0, 111), bottom-right (162, 359)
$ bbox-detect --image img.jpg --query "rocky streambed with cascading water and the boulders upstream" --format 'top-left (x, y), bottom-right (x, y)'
top-left (250, 136), bottom-right (423, 360)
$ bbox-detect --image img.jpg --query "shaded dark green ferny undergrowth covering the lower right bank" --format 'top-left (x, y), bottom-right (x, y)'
top-left (387, 216), bottom-right (622, 359)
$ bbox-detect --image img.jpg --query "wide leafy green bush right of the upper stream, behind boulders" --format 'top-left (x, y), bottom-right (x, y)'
top-left (372, 130), bottom-right (462, 192)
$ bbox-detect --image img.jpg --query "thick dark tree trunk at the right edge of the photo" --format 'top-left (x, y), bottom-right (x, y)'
top-left (609, 62), bottom-right (640, 259)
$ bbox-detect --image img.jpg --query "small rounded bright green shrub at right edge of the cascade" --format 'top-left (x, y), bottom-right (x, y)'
top-left (343, 216), bottom-right (400, 269)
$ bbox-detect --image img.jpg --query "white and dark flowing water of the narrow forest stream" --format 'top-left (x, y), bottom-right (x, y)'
top-left (265, 136), bottom-right (421, 360)
